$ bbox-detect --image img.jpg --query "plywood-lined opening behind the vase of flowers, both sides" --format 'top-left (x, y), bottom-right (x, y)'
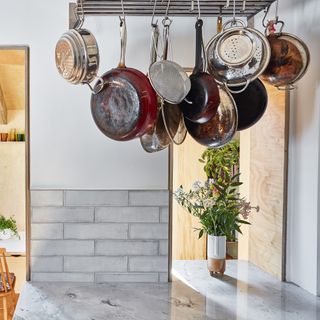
top-left (170, 84), bottom-right (289, 280)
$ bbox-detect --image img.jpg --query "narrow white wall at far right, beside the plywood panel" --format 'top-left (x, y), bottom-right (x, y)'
top-left (256, 0), bottom-right (320, 294)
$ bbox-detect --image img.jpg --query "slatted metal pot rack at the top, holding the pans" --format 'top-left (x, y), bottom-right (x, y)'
top-left (69, 0), bottom-right (275, 25)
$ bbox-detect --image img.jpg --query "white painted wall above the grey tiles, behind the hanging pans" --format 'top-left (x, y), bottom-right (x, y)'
top-left (0, 0), bottom-right (215, 189)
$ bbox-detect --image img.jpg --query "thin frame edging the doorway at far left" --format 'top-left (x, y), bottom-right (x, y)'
top-left (0, 45), bottom-right (31, 281)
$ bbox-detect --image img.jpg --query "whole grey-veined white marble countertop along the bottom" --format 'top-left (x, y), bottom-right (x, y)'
top-left (14, 261), bottom-right (320, 320)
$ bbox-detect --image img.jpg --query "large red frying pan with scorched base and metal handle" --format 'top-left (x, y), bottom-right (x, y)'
top-left (91, 18), bottom-right (157, 141)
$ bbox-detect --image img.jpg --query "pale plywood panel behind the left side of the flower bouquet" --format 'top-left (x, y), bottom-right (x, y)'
top-left (172, 135), bottom-right (206, 260)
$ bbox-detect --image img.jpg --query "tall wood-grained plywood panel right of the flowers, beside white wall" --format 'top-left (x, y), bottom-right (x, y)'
top-left (249, 85), bottom-right (286, 279)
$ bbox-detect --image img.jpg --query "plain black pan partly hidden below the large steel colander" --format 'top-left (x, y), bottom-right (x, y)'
top-left (233, 79), bottom-right (268, 131)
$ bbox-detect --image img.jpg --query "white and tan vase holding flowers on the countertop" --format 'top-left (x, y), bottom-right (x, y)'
top-left (207, 235), bottom-right (227, 276)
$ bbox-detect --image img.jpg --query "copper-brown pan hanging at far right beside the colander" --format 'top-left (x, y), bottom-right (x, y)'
top-left (262, 21), bottom-right (310, 89)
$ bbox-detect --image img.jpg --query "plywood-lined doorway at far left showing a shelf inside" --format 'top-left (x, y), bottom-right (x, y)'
top-left (0, 45), bottom-right (30, 292)
